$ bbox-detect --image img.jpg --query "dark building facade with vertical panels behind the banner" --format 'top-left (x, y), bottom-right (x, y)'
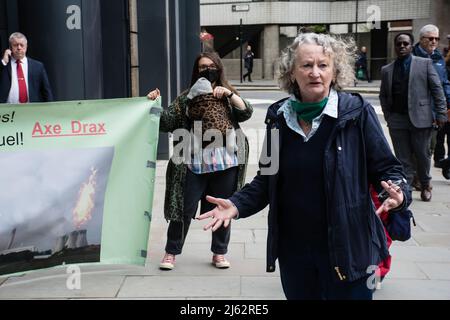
top-left (0, 0), bottom-right (201, 158)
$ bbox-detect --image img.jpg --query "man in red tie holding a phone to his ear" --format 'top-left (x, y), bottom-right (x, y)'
top-left (0, 32), bottom-right (53, 104)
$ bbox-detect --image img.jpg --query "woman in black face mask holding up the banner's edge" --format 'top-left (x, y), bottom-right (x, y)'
top-left (148, 52), bottom-right (253, 270)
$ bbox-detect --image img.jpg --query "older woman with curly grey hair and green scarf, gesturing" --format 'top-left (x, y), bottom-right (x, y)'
top-left (200, 33), bottom-right (411, 299)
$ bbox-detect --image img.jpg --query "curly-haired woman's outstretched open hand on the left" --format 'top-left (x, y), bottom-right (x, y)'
top-left (197, 196), bottom-right (239, 232)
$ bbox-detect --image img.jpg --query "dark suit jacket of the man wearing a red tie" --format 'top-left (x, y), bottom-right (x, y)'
top-left (0, 57), bottom-right (53, 103)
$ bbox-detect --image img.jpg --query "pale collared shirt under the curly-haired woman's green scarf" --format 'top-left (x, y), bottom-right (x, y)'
top-left (278, 89), bottom-right (339, 142)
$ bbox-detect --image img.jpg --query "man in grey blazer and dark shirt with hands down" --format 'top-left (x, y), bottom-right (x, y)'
top-left (380, 33), bottom-right (447, 201)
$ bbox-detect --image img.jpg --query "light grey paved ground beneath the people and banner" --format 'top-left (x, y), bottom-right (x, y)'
top-left (0, 86), bottom-right (450, 301)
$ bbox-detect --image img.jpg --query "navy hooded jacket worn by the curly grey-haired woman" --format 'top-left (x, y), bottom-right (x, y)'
top-left (230, 93), bottom-right (411, 281)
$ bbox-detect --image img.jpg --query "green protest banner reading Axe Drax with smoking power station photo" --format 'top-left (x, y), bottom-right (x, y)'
top-left (0, 98), bottom-right (161, 275)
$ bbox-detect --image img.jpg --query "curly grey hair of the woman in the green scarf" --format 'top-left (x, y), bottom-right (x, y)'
top-left (278, 33), bottom-right (357, 94)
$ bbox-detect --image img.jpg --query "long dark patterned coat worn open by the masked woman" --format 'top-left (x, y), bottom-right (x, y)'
top-left (160, 91), bottom-right (253, 222)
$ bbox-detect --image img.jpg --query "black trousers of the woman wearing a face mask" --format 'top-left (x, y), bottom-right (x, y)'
top-left (166, 167), bottom-right (238, 255)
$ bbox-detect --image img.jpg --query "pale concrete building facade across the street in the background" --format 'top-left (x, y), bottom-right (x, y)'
top-left (200, 0), bottom-right (450, 79)
